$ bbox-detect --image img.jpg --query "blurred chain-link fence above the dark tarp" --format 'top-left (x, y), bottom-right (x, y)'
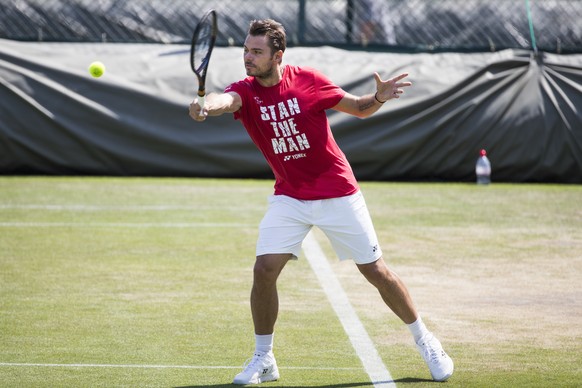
top-left (0, 0), bottom-right (582, 53)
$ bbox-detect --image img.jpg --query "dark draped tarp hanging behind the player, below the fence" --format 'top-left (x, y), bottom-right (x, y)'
top-left (0, 40), bottom-right (582, 183)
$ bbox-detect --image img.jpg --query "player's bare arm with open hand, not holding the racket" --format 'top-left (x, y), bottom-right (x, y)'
top-left (332, 73), bottom-right (412, 118)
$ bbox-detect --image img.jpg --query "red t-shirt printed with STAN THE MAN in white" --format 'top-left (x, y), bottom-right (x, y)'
top-left (225, 65), bottom-right (359, 200)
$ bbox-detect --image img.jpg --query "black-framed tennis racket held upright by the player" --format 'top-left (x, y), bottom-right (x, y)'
top-left (190, 9), bottom-right (218, 108)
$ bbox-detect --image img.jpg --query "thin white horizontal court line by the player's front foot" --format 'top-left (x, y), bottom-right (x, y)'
top-left (0, 362), bottom-right (360, 370)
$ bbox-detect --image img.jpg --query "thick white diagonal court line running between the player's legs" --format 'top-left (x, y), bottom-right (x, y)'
top-left (303, 231), bottom-right (396, 388)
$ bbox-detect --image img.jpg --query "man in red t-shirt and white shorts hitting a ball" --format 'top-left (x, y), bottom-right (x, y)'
top-left (190, 19), bottom-right (454, 384)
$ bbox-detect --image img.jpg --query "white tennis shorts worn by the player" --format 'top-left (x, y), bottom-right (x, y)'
top-left (256, 192), bottom-right (382, 264)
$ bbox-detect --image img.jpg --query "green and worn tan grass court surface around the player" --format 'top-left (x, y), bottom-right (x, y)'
top-left (0, 177), bottom-right (582, 387)
